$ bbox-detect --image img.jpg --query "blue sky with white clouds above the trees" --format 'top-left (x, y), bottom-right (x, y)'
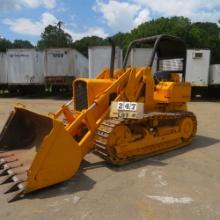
top-left (0, 0), bottom-right (220, 44)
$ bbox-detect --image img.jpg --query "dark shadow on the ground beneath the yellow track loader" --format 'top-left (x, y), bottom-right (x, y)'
top-left (15, 135), bottom-right (220, 202)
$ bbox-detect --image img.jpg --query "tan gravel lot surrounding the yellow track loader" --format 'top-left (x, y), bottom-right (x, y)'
top-left (0, 98), bottom-right (220, 220)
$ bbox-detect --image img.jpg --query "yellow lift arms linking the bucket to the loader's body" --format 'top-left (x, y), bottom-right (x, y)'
top-left (54, 68), bottom-right (133, 158)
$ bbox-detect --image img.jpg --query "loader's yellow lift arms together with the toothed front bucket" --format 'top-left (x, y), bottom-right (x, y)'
top-left (0, 65), bottom-right (149, 201)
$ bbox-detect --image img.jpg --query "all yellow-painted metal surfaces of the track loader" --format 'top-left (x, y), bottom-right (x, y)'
top-left (0, 50), bottom-right (196, 192)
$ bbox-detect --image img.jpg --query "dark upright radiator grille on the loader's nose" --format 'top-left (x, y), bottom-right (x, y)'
top-left (74, 81), bottom-right (88, 111)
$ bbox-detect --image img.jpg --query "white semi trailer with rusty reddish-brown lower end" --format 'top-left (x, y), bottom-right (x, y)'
top-left (44, 48), bottom-right (88, 90)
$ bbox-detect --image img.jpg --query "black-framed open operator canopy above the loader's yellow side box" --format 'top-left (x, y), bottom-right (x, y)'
top-left (123, 35), bottom-right (186, 85)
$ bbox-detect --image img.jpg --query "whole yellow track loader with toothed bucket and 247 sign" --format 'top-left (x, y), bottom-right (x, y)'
top-left (0, 35), bottom-right (197, 202)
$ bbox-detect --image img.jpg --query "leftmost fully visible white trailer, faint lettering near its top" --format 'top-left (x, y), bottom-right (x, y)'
top-left (6, 49), bottom-right (44, 93)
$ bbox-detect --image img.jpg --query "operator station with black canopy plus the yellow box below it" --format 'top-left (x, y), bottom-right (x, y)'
top-left (123, 35), bottom-right (191, 103)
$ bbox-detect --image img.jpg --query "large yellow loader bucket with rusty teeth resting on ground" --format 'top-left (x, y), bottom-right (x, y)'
top-left (0, 107), bottom-right (81, 202)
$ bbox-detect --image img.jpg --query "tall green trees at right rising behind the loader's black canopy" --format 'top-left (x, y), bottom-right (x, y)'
top-left (121, 16), bottom-right (220, 63)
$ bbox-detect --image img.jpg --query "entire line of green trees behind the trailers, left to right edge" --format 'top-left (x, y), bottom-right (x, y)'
top-left (0, 16), bottom-right (220, 63)
